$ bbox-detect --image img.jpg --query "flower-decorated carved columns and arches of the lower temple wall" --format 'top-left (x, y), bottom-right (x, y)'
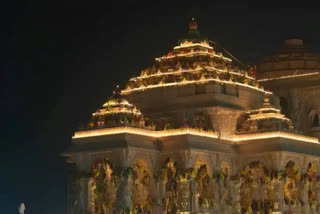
top-left (70, 155), bottom-right (320, 214)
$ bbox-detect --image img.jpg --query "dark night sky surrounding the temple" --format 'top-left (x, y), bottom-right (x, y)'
top-left (0, 0), bottom-right (320, 214)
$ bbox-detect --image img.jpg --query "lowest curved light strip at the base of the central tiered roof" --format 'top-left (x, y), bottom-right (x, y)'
top-left (121, 76), bottom-right (272, 94)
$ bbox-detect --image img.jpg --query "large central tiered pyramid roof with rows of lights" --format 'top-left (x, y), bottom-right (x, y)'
top-left (123, 20), bottom-right (263, 94)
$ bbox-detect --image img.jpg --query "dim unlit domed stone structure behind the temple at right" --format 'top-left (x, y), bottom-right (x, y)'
top-left (257, 39), bottom-right (320, 139)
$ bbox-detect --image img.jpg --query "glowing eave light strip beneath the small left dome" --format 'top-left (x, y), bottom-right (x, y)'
top-left (72, 127), bottom-right (218, 139)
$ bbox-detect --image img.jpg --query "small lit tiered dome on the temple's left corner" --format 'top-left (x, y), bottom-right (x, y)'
top-left (85, 86), bottom-right (144, 128)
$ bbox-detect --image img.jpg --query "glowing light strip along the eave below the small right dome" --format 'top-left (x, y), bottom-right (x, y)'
top-left (232, 131), bottom-right (319, 143)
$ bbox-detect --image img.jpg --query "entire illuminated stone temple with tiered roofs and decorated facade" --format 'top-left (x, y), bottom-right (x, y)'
top-left (63, 20), bottom-right (320, 214)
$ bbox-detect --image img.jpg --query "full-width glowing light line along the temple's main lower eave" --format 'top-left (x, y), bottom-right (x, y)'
top-left (72, 127), bottom-right (319, 144)
